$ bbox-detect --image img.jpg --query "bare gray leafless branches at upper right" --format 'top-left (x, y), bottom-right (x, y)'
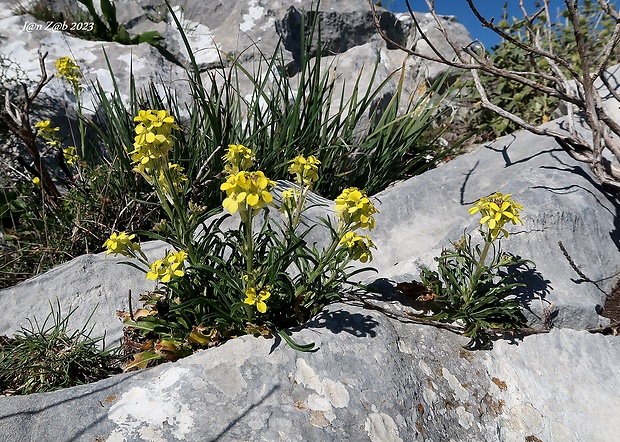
top-left (369, 0), bottom-right (620, 190)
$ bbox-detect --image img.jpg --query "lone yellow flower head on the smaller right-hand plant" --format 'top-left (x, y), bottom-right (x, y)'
top-left (469, 192), bottom-right (523, 239)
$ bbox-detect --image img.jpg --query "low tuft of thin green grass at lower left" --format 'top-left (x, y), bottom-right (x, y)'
top-left (0, 302), bottom-right (121, 395)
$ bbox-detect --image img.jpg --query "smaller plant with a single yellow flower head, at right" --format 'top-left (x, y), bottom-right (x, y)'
top-left (410, 192), bottom-right (533, 349)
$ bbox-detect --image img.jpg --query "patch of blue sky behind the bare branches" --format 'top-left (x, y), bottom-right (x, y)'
top-left (383, 0), bottom-right (564, 49)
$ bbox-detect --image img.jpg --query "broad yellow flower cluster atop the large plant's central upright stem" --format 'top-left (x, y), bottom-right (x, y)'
top-left (220, 171), bottom-right (276, 213)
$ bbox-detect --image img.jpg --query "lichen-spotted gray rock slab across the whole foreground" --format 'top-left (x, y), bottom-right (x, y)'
top-left (0, 304), bottom-right (620, 442)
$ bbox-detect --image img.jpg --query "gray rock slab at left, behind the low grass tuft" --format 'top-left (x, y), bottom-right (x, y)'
top-left (0, 241), bottom-right (166, 345)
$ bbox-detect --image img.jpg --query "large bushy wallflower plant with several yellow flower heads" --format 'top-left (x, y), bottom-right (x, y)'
top-left (105, 110), bottom-right (377, 370)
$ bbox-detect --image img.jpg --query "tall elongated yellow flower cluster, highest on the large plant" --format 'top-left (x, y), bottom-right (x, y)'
top-left (129, 110), bottom-right (178, 177)
